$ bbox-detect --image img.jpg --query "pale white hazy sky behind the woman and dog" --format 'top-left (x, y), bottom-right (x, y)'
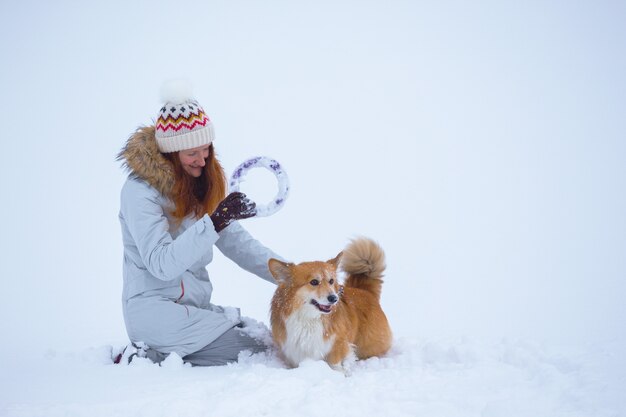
top-left (0, 1), bottom-right (626, 352)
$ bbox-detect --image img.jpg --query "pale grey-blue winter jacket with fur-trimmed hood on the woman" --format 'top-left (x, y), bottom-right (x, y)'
top-left (119, 128), bottom-right (278, 357)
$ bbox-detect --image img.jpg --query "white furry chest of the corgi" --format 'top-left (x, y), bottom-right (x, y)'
top-left (282, 312), bottom-right (335, 366)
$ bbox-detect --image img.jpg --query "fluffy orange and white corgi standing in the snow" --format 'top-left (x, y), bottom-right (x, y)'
top-left (268, 238), bottom-right (392, 374)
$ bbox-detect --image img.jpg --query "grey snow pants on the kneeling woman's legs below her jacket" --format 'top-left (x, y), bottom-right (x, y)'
top-left (146, 327), bottom-right (267, 366)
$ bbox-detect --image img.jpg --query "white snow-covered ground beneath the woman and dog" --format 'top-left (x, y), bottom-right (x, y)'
top-left (0, 324), bottom-right (626, 417)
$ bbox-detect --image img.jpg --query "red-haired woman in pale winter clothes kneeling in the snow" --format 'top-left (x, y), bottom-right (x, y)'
top-left (115, 90), bottom-right (277, 365)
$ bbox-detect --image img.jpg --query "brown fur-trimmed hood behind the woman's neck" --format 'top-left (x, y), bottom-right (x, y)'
top-left (117, 126), bottom-right (174, 198)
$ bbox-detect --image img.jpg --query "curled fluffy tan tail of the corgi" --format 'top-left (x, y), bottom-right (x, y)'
top-left (341, 237), bottom-right (386, 298)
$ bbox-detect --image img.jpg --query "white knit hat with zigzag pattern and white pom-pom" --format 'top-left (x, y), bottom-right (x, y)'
top-left (155, 80), bottom-right (215, 153)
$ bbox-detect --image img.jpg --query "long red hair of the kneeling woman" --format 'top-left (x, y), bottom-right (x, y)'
top-left (164, 144), bottom-right (226, 221)
